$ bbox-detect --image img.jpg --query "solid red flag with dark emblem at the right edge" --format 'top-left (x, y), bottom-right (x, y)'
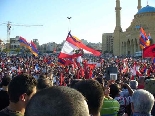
top-left (143, 44), bottom-right (155, 58)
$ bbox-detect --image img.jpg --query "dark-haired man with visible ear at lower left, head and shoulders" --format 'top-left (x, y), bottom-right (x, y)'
top-left (0, 74), bottom-right (37, 116)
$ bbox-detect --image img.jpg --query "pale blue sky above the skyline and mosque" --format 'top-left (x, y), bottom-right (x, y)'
top-left (0, 0), bottom-right (155, 44)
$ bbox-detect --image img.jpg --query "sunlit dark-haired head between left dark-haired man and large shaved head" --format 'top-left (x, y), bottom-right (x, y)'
top-left (37, 75), bottom-right (53, 91)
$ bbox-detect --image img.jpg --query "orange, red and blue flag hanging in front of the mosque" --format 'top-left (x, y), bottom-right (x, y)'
top-left (139, 27), bottom-right (150, 49)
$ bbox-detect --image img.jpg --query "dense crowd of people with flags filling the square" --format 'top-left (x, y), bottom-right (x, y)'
top-left (0, 54), bottom-right (155, 116)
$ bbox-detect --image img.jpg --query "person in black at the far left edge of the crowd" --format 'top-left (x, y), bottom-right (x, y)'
top-left (0, 76), bottom-right (11, 110)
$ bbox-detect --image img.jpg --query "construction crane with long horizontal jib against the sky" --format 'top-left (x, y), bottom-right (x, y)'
top-left (0, 21), bottom-right (43, 43)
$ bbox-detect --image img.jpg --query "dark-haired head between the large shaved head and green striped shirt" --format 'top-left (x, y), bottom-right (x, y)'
top-left (74, 80), bottom-right (104, 115)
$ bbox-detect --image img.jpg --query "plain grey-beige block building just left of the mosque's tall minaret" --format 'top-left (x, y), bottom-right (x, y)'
top-left (102, 33), bottom-right (114, 53)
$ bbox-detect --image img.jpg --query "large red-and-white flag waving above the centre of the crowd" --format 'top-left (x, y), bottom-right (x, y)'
top-left (58, 32), bottom-right (101, 58)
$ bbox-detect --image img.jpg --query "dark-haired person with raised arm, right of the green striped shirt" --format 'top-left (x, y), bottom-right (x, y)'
top-left (109, 83), bottom-right (133, 116)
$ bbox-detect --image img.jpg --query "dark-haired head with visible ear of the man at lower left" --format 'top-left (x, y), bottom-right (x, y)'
top-left (8, 74), bottom-right (37, 105)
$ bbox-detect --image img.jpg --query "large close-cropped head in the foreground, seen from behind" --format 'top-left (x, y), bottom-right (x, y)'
top-left (25, 86), bottom-right (89, 116)
